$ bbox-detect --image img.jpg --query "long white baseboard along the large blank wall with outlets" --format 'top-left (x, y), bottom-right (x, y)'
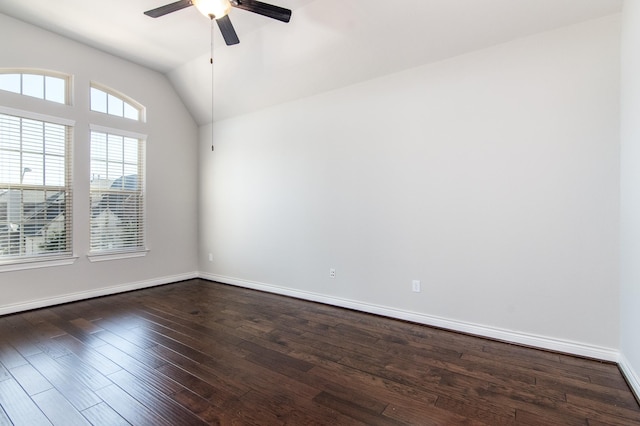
top-left (200, 273), bottom-right (619, 362)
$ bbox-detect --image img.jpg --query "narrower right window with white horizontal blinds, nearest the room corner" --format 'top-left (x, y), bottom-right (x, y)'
top-left (90, 126), bottom-right (145, 254)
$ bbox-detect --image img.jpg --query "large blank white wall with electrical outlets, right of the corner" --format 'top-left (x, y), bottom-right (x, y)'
top-left (199, 16), bottom-right (620, 359)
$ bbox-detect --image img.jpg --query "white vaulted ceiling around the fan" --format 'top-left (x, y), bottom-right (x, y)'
top-left (0, 0), bottom-right (622, 124)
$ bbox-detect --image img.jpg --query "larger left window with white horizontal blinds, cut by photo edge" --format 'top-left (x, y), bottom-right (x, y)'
top-left (0, 113), bottom-right (73, 263)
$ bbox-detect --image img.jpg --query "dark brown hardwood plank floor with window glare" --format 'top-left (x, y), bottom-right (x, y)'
top-left (0, 280), bottom-right (640, 426)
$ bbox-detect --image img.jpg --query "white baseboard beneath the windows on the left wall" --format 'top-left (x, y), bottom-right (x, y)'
top-left (0, 272), bottom-right (198, 315)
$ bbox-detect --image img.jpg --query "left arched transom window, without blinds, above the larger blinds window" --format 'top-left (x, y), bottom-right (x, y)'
top-left (0, 70), bottom-right (69, 104)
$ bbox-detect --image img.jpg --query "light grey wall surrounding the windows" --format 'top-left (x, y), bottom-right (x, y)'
top-left (0, 15), bottom-right (198, 313)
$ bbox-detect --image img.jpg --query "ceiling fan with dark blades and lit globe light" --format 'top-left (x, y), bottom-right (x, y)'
top-left (144, 0), bottom-right (291, 46)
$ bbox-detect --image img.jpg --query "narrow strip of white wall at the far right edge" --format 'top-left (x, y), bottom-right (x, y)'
top-left (620, 1), bottom-right (640, 398)
